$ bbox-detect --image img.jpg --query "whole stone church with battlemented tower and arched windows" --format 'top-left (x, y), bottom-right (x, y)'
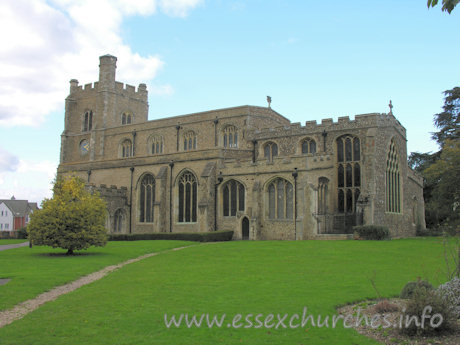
top-left (58, 55), bottom-right (425, 240)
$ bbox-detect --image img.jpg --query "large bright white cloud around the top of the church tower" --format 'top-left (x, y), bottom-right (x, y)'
top-left (0, 0), bottom-right (202, 125)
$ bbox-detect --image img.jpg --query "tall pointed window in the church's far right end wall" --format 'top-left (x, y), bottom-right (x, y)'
top-left (385, 139), bottom-right (401, 213)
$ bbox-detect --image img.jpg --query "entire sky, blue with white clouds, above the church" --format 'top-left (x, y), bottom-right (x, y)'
top-left (0, 0), bottom-right (460, 202)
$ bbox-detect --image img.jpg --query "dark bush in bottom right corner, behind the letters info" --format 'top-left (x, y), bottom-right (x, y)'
top-left (400, 288), bottom-right (458, 336)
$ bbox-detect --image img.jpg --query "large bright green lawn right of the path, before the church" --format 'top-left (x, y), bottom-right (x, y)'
top-left (0, 238), bottom-right (452, 345)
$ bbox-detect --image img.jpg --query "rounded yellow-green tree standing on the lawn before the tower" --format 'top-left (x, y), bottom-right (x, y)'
top-left (27, 177), bottom-right (107, 255)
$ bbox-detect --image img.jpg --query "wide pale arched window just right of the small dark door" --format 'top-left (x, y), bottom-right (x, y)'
top-left (267, 178), bottom-right (294, 219)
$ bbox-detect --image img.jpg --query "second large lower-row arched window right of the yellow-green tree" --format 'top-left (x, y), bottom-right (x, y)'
top-left (178, 171), bottom-right (197, 223)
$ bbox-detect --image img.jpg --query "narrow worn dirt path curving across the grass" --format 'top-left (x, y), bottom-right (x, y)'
top-left (0, 243), bottom-right (194, 328)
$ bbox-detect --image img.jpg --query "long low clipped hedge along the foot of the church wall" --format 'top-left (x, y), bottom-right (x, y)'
top-left (109, 231), bottom-right (233, 242)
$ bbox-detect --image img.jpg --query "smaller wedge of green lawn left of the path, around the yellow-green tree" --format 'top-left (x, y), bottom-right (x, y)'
top-left (0, 241), bottom-right (195, 310)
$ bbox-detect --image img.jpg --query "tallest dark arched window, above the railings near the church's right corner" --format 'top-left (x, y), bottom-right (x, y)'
top-left (337, 135), bottom-right (361, 213)
